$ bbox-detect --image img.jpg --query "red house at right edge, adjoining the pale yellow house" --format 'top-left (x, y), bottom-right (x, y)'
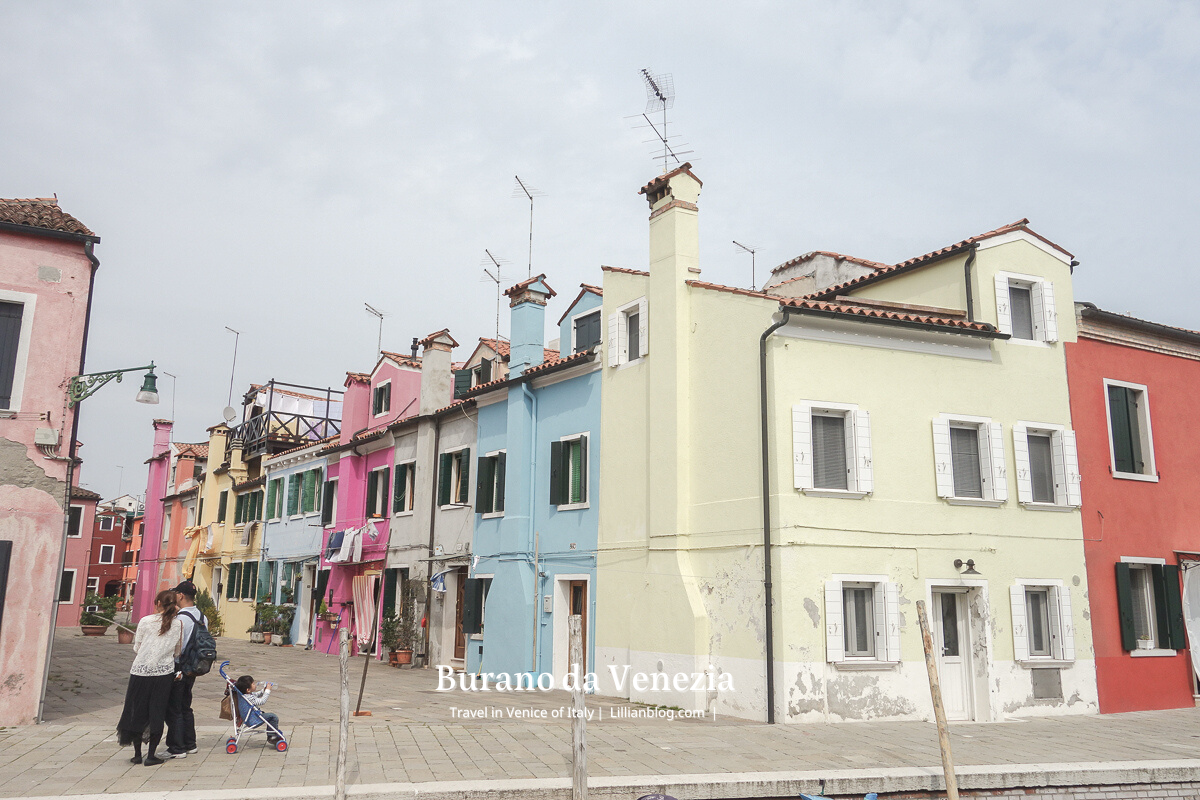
top-left (1067, 303), bottom-right (1200, 712)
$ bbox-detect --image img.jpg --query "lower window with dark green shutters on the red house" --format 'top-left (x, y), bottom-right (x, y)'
top-left (1117, 559), bottom-right (1187, 655)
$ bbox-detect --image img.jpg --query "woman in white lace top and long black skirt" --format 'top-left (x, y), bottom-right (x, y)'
top-left (116, 591), bottom-right (184, 766)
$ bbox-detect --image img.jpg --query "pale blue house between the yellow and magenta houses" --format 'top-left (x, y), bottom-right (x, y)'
top-left (258, 440), bottom-right (328, 645)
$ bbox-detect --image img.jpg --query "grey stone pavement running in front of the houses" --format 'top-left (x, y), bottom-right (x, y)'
top-left (7, 631), bottom-right (1200, 798)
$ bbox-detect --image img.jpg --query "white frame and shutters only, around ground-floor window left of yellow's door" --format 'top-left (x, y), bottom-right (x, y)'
top-left (824, 575), bottom-right (901, 669)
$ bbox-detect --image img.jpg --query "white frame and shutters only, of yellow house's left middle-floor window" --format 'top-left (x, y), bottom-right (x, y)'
top-left (792, 401), bottom-right (875, 500)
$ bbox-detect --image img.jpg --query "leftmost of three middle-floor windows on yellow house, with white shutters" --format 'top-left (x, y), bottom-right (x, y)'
top-left (792, 401), bottom-right (875, 498)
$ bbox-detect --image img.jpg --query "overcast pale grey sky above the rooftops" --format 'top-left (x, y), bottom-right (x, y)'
top-left (0, 0), bottom-right (1200, 497)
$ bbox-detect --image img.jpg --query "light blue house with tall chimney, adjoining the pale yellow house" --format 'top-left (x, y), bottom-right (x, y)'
top-left (463, 275), bottom-right (601, 685)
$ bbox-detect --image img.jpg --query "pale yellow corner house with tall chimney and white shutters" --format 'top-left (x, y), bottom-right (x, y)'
top-left (595, 166), bottom-right (1097, 722)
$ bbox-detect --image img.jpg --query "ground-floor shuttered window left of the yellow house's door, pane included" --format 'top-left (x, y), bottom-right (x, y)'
top-left (826, 575), bottom-right (900, 664)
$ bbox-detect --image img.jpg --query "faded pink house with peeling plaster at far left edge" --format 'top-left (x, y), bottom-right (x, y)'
top-left (0, 199), bottom-right (100, 727)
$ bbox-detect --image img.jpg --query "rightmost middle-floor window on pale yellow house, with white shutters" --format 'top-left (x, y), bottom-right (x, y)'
top-left (1013, 422), bottom-right (1082, 507)
